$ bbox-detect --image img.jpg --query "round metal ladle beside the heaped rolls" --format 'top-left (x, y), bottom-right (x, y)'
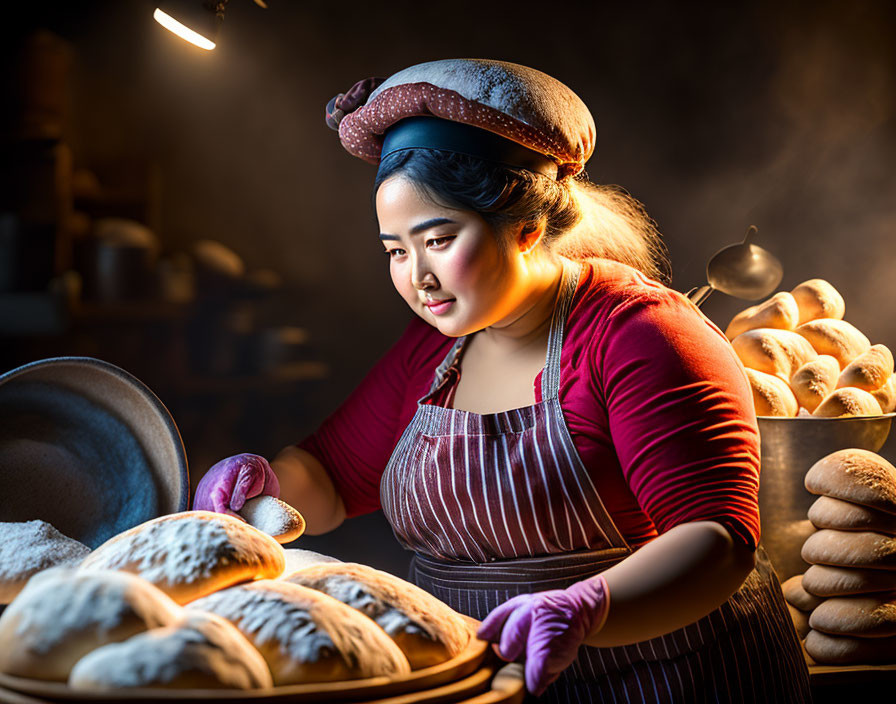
top-left (685, 225), bottom-right (784, 307)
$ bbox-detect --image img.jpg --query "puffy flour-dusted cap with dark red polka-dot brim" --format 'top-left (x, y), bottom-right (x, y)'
top-left (326, 59), bottom-right (596, 178)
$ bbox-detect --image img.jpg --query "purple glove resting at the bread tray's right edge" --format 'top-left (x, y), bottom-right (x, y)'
top-left (478, 575), bottom-right (610, 696)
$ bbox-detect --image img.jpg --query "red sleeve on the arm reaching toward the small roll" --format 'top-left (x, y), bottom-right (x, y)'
top-left (297, 317), bottom-right (452, 518)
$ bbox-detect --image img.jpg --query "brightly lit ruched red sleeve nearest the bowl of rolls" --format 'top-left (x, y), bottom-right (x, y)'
top-left (597, 289), bottom-right (759, 548)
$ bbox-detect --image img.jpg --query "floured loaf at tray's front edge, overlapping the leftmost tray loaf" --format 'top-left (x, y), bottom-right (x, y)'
top-left (68, 611), bottom-right (273, 691)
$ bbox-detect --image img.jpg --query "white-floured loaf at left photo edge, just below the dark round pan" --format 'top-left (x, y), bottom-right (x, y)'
top-left (0, 520), bottom-right (90, 604)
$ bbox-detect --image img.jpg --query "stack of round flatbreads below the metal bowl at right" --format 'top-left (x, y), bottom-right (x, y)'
top-left (782, 449), bottom-right (896, 664)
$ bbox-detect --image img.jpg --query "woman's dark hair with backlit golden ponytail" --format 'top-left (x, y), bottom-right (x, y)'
top-left (373, 149), bottom-right (671, 283)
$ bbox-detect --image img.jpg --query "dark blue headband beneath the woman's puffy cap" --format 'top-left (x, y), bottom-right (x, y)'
top-left (380, 117), bottom-right (557, 179)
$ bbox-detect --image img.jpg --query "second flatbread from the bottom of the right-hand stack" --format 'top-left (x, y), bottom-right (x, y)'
top-left (809, 594), bottom-right (896, 638)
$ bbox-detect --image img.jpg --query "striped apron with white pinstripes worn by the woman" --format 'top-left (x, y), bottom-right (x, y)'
top-left (380, 261), bottom-right (810, 704)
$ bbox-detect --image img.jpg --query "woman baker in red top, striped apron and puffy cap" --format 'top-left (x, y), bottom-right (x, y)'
top-left (194, 59), bottom-right (808, 702)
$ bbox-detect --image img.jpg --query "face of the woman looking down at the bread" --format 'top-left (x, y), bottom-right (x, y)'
top-left (376, 176), bottom-right (525, 337)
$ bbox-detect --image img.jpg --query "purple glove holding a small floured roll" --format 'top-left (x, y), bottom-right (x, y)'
top-left (193, 453), bottom-right (280, 516)
